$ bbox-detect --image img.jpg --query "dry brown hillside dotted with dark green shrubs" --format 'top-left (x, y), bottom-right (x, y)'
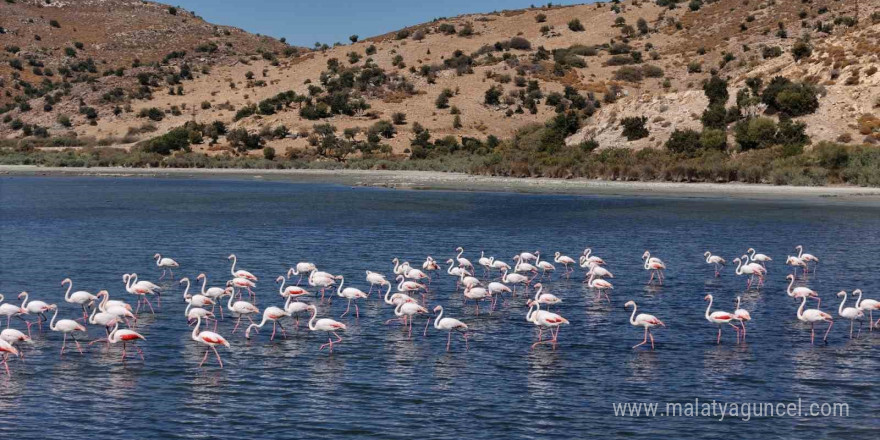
top-left (0, 0), bottom-right (880, 181)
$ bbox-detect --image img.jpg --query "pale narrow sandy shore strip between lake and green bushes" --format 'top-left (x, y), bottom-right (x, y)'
top-left (0, 165), bottom-right (880, 205)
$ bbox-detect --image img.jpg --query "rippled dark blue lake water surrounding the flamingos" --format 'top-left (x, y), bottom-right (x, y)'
top-left (0, 178), bottom-right (880, 439)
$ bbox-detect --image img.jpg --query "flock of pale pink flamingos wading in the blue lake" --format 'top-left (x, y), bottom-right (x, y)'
top-left (0, 246), bottom-right (880, 374)
